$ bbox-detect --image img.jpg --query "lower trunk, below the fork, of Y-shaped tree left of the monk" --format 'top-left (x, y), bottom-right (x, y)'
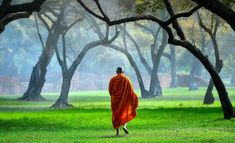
top-left (52, 73), bottom-right (73, 108)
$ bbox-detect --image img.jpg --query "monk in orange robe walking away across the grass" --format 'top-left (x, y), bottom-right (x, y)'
top-left (109, 67), bottom-right (138, 136)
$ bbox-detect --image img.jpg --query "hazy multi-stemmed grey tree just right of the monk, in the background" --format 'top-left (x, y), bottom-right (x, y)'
top-left (109, 19), bottom-right (171, 98)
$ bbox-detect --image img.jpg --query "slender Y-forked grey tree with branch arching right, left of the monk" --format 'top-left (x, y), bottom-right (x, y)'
top-left (52, 12), bottom-right (119, 108)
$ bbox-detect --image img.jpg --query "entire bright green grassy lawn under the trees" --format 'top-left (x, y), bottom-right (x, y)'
top-left (0, 88), bottom-right (235, 143)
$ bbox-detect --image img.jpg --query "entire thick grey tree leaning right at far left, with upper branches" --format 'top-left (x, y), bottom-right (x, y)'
top-left (19, 2), bottom-right (68, 101)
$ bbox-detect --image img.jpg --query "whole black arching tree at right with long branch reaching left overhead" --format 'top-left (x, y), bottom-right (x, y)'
top-left (77, 0), bottom-right (234, 119)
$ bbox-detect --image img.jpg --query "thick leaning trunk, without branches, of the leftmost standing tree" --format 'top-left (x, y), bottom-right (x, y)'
top-left (19, 31), bottom-right (60, 101)
